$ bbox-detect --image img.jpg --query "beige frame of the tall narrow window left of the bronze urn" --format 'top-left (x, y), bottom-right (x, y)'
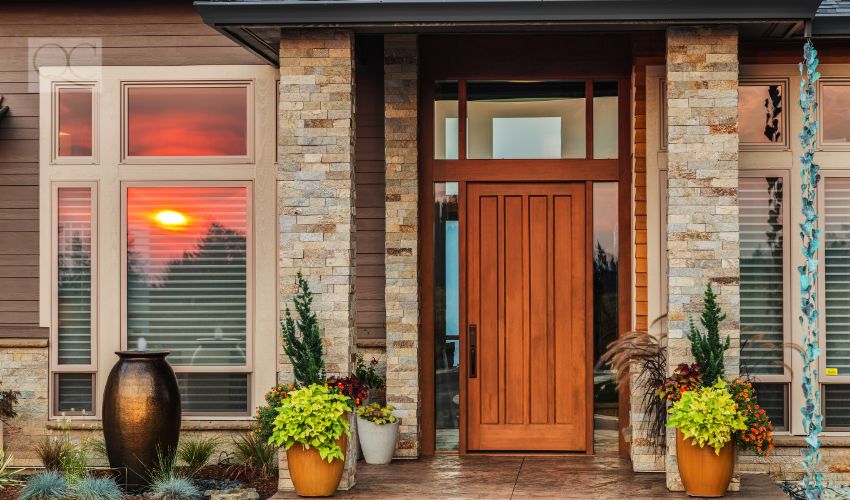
top-left (48, 182), bottom-right (100, 419)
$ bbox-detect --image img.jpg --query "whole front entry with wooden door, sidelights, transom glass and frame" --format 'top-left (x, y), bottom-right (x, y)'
top-left (419, 35), bottom-right (631, 455)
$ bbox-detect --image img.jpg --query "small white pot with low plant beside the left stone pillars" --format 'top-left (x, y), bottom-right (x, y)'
top-left (357, 403), bottom-right (399, 465)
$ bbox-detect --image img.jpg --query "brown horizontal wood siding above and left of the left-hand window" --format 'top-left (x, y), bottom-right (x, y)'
top-left (0, 1), bottom-right (262, 337)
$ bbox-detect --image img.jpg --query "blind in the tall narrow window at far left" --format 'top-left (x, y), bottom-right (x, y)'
top-left (56, 187), bottom-right (92, 365)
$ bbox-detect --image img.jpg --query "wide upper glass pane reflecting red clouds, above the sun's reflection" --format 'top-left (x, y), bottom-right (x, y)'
top-left (127, 85), bottom-right (248, 156)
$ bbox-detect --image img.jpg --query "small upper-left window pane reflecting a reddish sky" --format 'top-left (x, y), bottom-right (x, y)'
top-left (56, 87), bottom-right (92, 157)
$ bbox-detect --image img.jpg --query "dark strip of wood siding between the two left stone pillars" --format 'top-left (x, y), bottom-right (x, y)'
top-left (354, 36), bottom-right (386, 345)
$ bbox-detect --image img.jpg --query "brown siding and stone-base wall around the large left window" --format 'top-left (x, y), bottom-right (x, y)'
top-left (0, 1), bottom-right (262, 466)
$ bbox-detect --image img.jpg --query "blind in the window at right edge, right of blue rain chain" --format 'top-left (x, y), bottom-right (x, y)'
top-left (824, 177), bottom-right (850, 375)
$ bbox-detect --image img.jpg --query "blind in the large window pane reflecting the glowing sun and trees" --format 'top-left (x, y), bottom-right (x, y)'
top-left (126, 187), bottom-right (249, 370)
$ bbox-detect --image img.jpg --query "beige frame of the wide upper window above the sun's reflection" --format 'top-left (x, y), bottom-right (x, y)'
top-left (120, 79), bottom-right (256, 165)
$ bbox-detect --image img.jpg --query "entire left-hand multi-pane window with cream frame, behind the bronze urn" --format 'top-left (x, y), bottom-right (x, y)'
top-left (39, 65), bottom-right (280, 418)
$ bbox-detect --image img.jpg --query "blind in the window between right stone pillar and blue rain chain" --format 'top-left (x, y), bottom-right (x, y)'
top-left (738, 177), bottom-right (785, 375)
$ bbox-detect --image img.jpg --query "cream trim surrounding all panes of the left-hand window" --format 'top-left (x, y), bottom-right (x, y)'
top-left (39, 65), bottom-right (279, 421)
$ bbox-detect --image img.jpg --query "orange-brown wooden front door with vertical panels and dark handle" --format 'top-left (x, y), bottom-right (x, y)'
top-left (466, 183), bottom-right (590, 451)
